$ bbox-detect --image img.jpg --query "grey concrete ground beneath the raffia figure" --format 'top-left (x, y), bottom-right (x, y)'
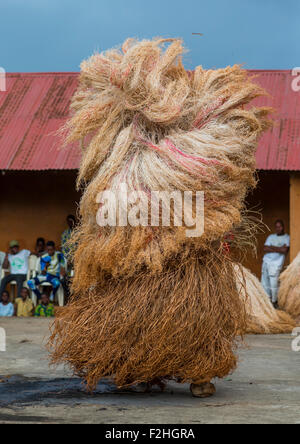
top-left (0, 318), bottom-right (300, 424)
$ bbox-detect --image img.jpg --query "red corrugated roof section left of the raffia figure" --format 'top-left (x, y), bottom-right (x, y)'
top-left (0, 73), bottom-right (81, 170)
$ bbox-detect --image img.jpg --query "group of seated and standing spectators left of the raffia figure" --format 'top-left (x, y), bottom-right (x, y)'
top-left (0, 215), bottom-right (76, 317)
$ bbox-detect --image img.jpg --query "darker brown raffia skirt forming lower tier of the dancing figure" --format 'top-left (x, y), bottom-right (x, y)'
top-left (53, 251), bottom-right (245, 388)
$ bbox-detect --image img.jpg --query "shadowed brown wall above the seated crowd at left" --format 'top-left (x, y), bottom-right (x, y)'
top-left (0, 171), bottom-right (80, 251)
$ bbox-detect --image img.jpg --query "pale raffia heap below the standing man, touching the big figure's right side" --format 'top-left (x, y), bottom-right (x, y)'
top-left (235, 266), bottom-right (296, 334)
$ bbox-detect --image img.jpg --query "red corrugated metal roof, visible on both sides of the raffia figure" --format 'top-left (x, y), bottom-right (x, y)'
top-left (0, 70), bottom-right (300, 170)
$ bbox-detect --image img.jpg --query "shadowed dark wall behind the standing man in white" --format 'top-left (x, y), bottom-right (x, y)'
top-left (245, 171), bottom-right (290, 277)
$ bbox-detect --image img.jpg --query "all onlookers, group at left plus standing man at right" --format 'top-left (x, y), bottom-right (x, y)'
top-left (0, 215), bottom-right (290, 317)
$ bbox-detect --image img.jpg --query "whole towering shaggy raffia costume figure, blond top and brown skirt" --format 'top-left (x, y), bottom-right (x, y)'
top-left (51, 39), bottom-right (269, 396)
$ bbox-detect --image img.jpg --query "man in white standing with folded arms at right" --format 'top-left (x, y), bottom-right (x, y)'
top-left (261, 220), bottom-right (290, 308)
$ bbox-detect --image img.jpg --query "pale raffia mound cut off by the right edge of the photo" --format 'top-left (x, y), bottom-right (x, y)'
top-left (278, 253), bottom-right (300, 323)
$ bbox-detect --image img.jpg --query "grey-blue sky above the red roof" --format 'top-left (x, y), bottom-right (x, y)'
top-left (0, 0), bottom-right (300, 72)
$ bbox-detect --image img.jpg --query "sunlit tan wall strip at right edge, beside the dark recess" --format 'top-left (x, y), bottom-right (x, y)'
top-left (290, 173), bottom-right (300, 260)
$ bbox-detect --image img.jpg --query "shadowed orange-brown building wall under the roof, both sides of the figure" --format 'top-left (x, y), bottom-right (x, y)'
top-left (0, 171), bottom-right (290, 276)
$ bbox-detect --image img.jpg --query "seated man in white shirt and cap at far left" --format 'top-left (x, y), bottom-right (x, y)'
top-left (0, 241), bottom-right (31, 297)
